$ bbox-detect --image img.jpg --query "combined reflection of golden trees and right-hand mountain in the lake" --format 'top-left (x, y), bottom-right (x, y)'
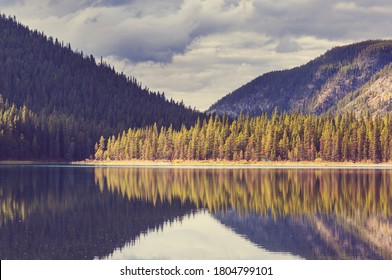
top-left (95, 168), bottom-right (392, 259)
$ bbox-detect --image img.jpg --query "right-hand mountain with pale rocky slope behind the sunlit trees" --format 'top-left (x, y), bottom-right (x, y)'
top-left (208, 40), bottom-right (392, 117)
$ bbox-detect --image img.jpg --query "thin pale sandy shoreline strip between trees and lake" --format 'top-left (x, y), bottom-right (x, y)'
top-left (0, 160), bottom-right (392, 169)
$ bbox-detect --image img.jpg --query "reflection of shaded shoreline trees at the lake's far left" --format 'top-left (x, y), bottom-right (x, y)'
top-left (0, 166), bottom-right (87, 226)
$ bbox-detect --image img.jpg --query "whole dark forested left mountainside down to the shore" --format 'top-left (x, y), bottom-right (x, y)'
top-left (0, 15), bottom-right (204, 160)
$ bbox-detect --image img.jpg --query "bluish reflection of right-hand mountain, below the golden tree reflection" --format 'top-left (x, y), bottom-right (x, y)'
top-left (215, 210), bottom-right (381, 259)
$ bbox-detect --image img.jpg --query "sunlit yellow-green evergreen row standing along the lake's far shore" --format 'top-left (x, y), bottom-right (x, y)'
top-left (95, 110), bottom-right (392, 163)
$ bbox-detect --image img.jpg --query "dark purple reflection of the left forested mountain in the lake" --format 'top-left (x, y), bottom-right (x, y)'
top-left (0, 167), bottom-right (194, 259)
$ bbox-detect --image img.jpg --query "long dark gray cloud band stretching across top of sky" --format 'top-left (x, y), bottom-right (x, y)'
top-left (0, 0), bottom-right (392, 63)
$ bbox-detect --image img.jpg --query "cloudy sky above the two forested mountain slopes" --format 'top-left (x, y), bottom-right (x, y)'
top-left (0, 0), bottom-right (392, 110)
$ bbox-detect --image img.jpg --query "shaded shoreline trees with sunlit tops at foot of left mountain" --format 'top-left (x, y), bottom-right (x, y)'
top-left (0, 95), bottom-right (90, 160)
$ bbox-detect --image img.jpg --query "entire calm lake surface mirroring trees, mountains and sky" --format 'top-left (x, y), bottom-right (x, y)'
top-left (0, 165), bottom-right (392, 259)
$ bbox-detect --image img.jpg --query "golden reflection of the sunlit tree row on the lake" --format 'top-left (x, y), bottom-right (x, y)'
top-left (95, 168), bottom-right (392, 218)
